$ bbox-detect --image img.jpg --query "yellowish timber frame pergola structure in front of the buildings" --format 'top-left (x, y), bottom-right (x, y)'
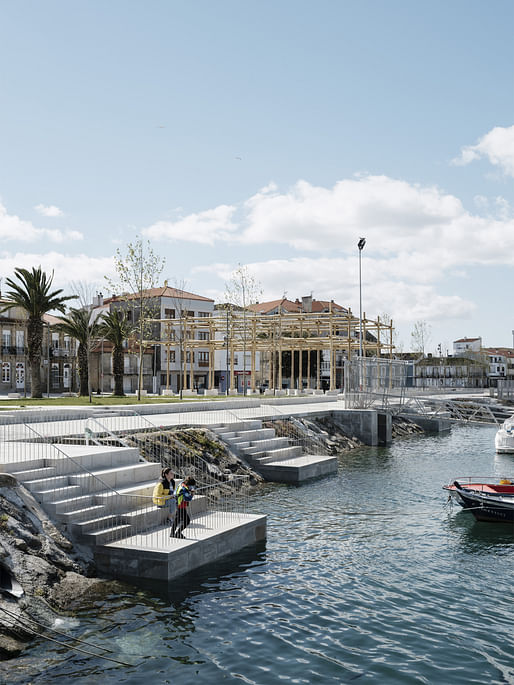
top-left (144, 307), bottom-right (394, 392)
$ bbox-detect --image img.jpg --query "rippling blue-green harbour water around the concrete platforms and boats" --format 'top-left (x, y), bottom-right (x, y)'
top-left (0, 427), bottom-right (514, 685)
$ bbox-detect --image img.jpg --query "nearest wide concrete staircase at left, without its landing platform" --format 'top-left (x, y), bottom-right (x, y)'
top-left (0, 443), bottom-right (206, 546)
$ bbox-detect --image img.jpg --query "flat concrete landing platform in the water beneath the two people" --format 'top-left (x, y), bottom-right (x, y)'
top-left (94, 512), bottom-right (266, 581)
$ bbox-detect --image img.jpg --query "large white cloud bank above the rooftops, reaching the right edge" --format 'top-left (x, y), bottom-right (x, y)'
top-left (142, 176), bottom-right (514, 269)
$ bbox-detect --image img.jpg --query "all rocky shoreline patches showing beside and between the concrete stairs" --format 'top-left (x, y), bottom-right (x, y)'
top-left (0, 417), bottom-right (423, 660)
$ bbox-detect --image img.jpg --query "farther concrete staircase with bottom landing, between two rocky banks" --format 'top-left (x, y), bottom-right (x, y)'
top-left (212, 420), bottom-right (337, 484)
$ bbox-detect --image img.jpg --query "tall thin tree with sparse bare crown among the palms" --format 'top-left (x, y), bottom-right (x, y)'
top-left (105, 237), bottom-right (165, 400)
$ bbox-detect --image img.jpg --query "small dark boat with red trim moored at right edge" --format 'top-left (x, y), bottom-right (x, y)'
top-left (443, 477), bottom-right (514, 523)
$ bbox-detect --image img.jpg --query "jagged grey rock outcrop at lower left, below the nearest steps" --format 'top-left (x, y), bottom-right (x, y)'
top-left (0, 473), bottom-right (119, 659)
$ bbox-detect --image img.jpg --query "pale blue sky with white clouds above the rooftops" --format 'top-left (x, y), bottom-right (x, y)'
top-left (0, 0), bottom-right (514, 354)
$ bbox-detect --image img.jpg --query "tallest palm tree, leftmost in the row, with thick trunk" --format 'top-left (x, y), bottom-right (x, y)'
top-left (1, 266), bottom-right (75, 398)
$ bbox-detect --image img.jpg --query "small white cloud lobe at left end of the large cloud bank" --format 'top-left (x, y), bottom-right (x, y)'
top-left (142, 205), bottom-right (237, 245)
